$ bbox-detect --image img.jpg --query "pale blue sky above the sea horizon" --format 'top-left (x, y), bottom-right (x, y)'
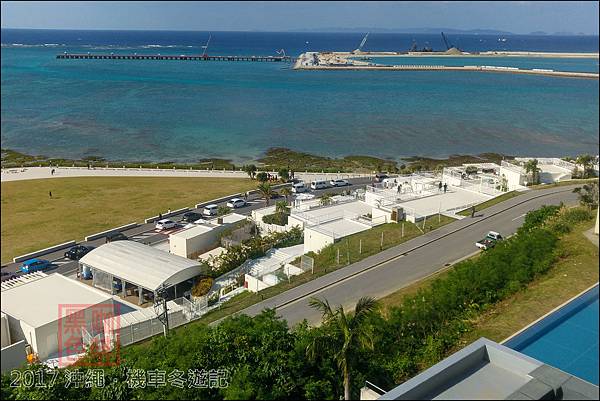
top-left (1, 1), bottom-right (599, 35)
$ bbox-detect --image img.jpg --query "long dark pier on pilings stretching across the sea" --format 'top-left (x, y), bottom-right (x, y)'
top-left (56, 53), bottom-right (295, 63)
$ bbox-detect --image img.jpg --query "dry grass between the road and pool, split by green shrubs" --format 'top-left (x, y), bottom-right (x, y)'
top-left (380, 220), bottom-right (598, 355)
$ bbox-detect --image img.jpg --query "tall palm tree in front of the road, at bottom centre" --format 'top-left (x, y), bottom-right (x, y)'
top-left (306, 297), bottom-right (379, 400)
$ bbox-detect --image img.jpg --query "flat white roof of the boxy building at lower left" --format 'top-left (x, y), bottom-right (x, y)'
top-left (1, 273), bottom-right (112, 327)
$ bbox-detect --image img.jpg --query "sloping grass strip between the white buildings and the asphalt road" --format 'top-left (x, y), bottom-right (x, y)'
top-left (183, 216), bottom-right (454, 323)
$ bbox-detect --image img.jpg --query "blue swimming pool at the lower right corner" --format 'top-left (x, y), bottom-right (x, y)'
top-left (503, 285), bottom-right (598, 385)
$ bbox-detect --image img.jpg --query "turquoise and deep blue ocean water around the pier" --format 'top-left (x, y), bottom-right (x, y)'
top-left (1, 31), bottom-right (599, 162)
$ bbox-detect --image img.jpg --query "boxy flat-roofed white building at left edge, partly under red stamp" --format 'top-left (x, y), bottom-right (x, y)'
top-left (1, 272), bottom-right (115, 369)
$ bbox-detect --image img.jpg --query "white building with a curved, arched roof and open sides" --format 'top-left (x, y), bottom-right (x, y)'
top-left (79, 241), bottom-right (201, 305)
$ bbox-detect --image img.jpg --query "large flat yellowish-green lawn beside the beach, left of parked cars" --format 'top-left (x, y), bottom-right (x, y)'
top-left (1, 177), bottom-right (256, 263)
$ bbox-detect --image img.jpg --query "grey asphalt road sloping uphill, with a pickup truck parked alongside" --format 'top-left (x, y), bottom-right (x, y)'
top-left (233, 186), bottom-right (577, 325)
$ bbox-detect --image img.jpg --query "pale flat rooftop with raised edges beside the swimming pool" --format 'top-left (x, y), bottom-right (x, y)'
top-left (379, 338), bottom-right (598, 400)
